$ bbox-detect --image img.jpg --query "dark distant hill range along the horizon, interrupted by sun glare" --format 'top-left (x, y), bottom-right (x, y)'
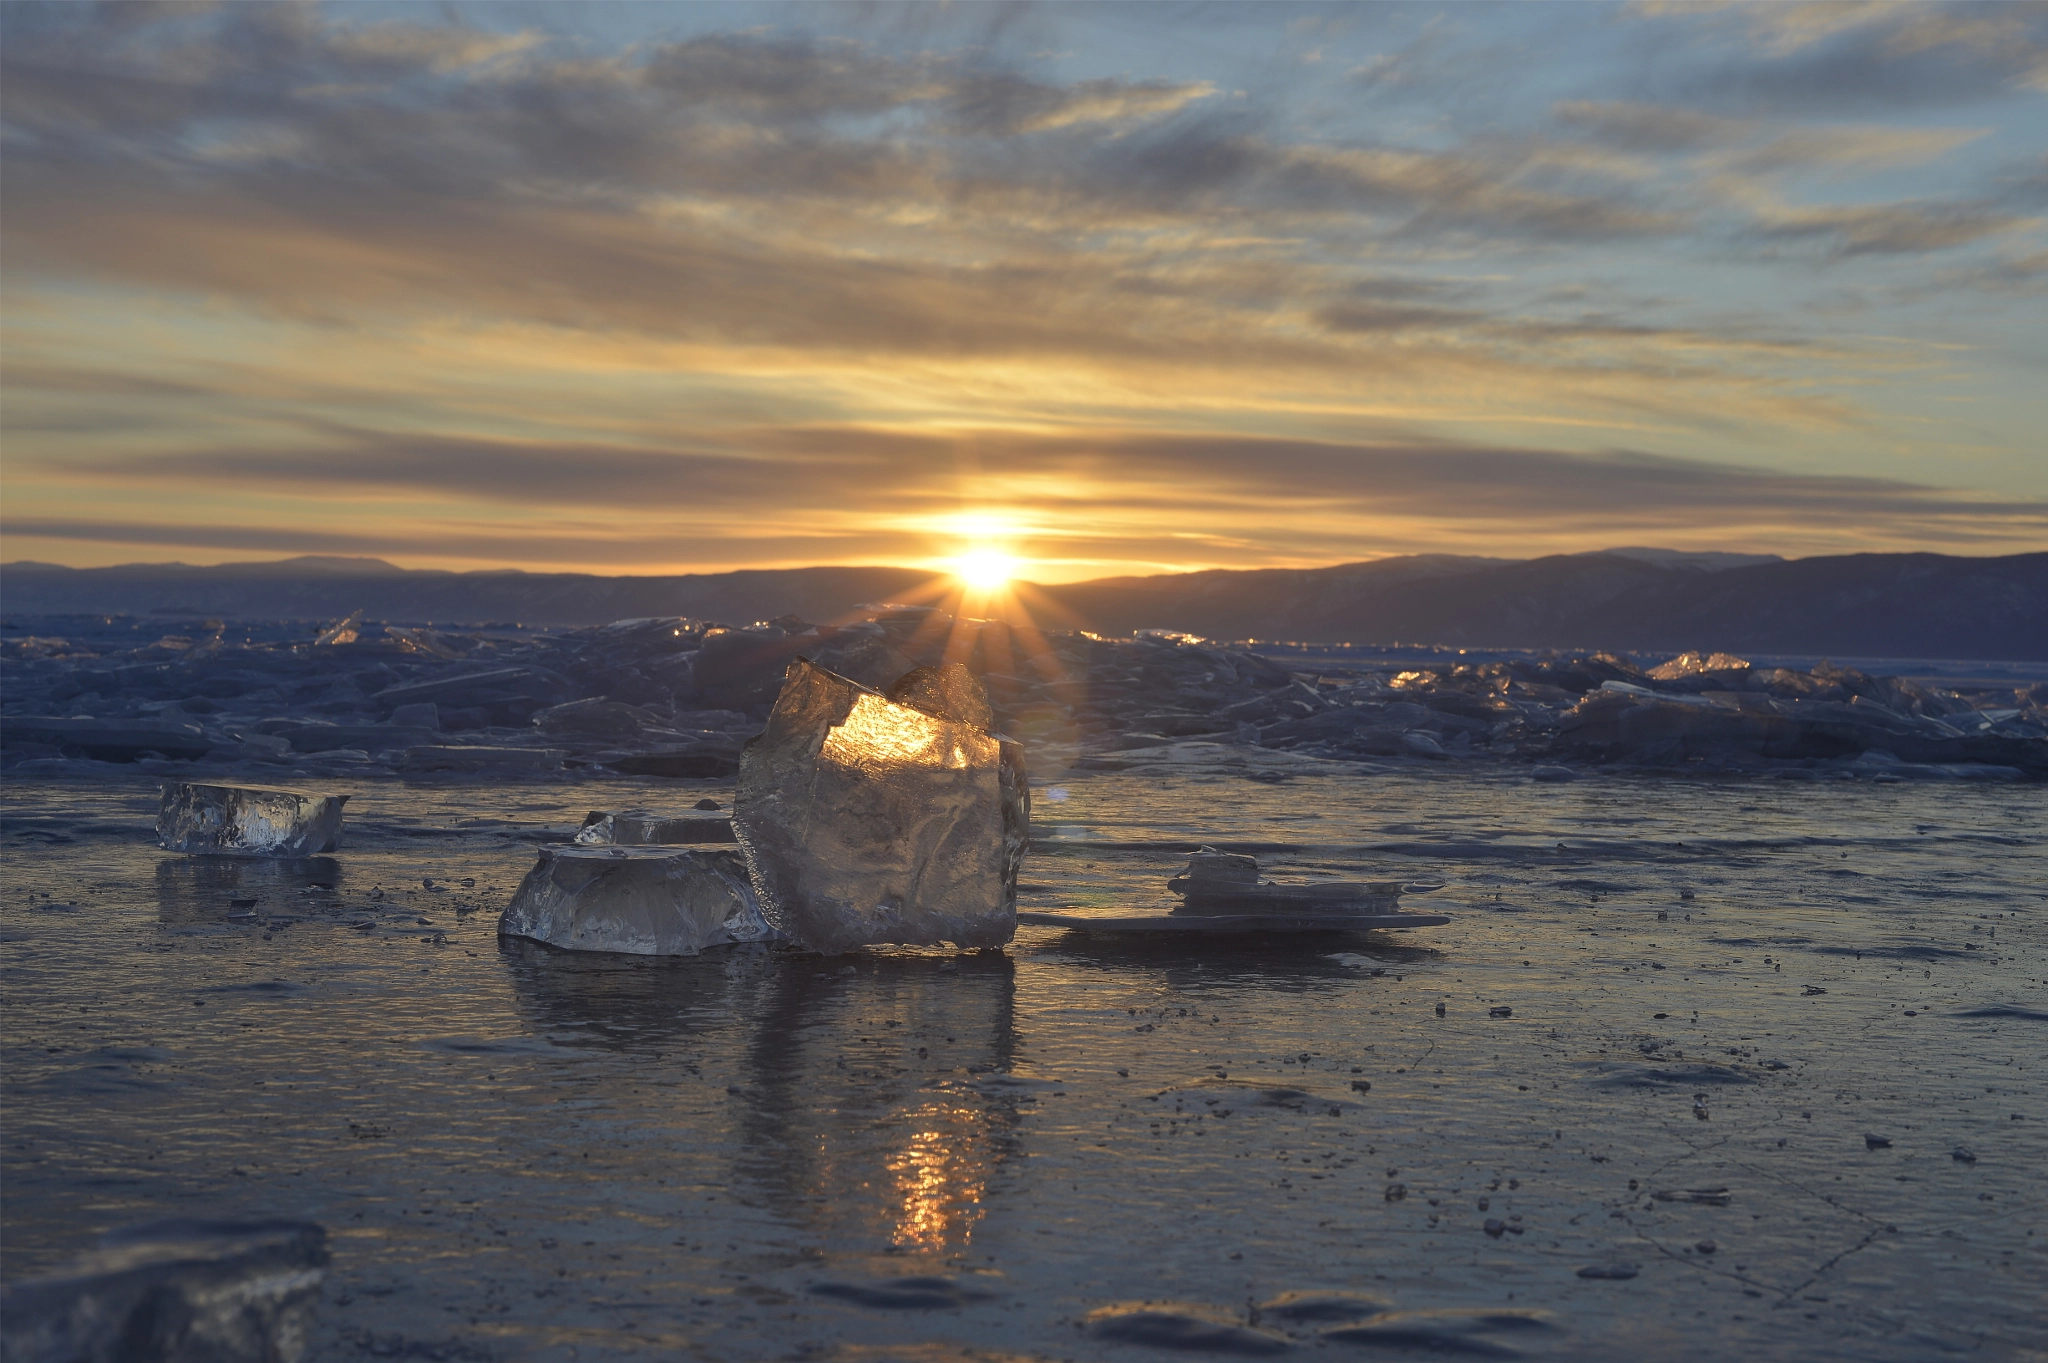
top-left (0, 548), bottom-right (2048, 659)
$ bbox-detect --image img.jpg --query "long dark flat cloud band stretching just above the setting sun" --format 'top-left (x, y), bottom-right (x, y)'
top-left (48, 426), bottom-right (2048, 524)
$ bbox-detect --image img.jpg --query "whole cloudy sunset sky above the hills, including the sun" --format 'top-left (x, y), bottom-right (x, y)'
top-left (0, 0), bottom-right (2048, 581)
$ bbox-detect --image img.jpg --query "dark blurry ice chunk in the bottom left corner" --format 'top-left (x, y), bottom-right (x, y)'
top-left (0, 1222), bottom-right (328, 1363)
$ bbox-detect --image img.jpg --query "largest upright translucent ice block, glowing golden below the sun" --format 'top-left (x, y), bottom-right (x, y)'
top-left (733, 659), bottom-right (1030, 952)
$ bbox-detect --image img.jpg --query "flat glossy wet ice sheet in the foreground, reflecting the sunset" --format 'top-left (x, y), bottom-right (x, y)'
top-left (0, 772), bottom-right (2048, 1359)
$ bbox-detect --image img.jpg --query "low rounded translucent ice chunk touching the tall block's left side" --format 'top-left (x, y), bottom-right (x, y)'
top-left (498, 847), bottom-right (776, 956)
